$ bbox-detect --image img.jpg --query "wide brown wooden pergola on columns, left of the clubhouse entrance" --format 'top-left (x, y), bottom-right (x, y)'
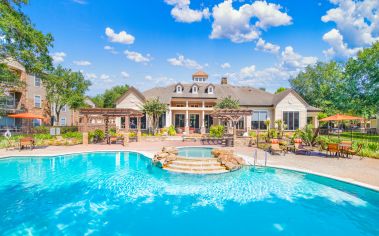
top-left (79, 108), bottom-right (144, 144)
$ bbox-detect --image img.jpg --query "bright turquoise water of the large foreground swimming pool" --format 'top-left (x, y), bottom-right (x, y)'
top-left (0, 153), bottom-right (379, 236)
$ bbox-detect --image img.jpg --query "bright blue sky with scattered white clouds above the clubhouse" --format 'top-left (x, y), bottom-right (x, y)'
top-left (23, 0), bottom-right (379, 96)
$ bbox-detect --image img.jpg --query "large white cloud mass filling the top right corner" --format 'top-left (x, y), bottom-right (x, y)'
top-left (321, 0), bottom-right (379, 58)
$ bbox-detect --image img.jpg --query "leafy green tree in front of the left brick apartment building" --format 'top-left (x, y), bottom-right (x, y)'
top-left (43, 66), bottom-right (91, 125)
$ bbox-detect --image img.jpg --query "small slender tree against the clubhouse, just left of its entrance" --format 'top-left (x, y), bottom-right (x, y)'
top-left (142, 98), bottom-right (167, 133)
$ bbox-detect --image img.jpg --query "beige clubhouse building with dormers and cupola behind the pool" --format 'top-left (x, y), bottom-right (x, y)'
top-left (115, 71), bottom-right (321, 133)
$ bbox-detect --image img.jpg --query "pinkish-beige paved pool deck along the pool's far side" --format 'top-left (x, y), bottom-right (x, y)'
top-left (0, 141), bottom-right (379, 191)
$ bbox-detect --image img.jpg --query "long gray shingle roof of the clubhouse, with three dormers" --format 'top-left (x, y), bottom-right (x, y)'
top-left (142, 83), bottom-right (320, 111)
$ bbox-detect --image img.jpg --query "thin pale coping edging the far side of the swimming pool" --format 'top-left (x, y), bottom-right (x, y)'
top-left (0, 146), bottom-right (379, 192)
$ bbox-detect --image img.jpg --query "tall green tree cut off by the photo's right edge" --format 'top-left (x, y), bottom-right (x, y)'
top-left (344, 42), bottom-right (379, 117)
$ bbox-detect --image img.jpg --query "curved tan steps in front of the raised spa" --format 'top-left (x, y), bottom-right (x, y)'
top-left (163, 158), bottom-right (229, 174)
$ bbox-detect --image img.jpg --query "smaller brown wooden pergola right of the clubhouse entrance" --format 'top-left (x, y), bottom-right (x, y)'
top-left (211, 109), bottom-right (253, 139)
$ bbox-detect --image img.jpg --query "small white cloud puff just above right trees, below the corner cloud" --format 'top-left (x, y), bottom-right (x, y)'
top-left (322, 29), bottom-right (362, 59)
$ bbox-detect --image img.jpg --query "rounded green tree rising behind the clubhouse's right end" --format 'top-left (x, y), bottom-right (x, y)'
top-left (290, 61), bottom-right (346, 114)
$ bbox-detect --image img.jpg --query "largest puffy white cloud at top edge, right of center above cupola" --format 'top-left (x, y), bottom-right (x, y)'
top-left (210, 0), bottom-right (292, 43)
